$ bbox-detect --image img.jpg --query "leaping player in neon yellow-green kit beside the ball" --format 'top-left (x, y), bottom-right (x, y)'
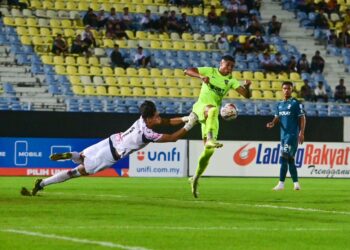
top-left (185, 55), bottom-right (251, 198)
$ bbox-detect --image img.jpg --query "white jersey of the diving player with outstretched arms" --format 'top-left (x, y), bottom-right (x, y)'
top-left (110, 117), bottom-right (163, 158)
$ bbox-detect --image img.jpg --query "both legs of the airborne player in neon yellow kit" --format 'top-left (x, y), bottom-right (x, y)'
top-left (190, 106), bottom-right (223, 198)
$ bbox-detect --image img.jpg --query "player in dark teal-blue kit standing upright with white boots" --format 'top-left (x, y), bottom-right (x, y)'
top-left (266, 81), bottom-right (306, 191)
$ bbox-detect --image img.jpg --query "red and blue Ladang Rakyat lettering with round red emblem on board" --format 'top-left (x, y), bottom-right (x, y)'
top-left (233, 143), bottom-right (350, 169)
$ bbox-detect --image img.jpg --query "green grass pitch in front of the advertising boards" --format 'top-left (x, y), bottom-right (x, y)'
top-left (0, 177), bottom-right (350, 250)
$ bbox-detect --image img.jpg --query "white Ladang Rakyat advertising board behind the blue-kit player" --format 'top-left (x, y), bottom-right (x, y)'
top-left (189, 141), bottom-right (350, 178)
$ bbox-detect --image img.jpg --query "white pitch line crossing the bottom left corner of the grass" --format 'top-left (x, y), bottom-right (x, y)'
top-left (1, 229), bottom-right (149, 250)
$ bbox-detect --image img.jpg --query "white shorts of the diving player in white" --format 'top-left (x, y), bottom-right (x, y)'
top-left (83, 138), bottom-right (117, 174)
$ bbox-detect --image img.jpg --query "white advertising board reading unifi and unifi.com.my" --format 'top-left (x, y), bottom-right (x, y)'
top-left (129, 140), bottom-right (188, 177)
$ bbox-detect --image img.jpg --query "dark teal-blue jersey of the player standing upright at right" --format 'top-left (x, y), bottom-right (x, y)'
top-left (275, 98), bottom-right (305, 140)
